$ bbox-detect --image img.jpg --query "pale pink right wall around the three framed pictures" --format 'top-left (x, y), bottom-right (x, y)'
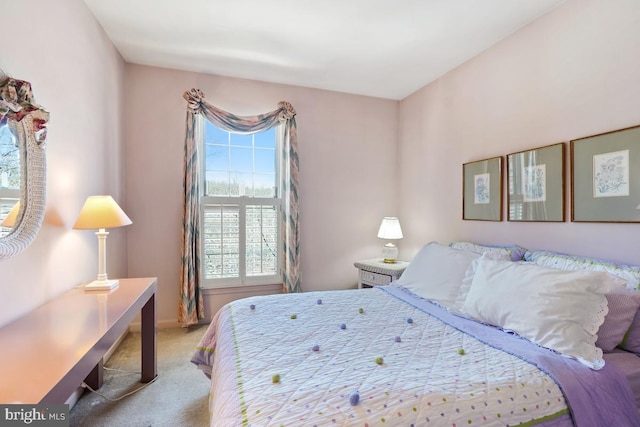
top-left (398, 0), bottom-right (640, 264)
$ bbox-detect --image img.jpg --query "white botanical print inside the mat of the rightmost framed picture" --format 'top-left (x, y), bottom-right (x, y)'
top-left (593, 150), bottom-right (629, 197)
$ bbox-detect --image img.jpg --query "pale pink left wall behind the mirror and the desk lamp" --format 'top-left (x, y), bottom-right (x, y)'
top-left (0, 0), bottom-right (127, 325)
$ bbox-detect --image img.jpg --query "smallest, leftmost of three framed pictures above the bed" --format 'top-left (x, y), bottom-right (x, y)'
top-left (462, 157), bottom-right (502, 221)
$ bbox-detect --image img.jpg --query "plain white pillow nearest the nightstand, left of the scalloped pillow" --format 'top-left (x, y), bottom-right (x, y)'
top-left (397, 242), bottom-right (480, 308)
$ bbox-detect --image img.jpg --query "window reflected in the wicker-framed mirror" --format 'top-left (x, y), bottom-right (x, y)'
top-left (0, 124), bottom-right (20, 237)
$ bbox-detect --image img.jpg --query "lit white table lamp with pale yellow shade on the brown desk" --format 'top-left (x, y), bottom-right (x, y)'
top-left (73, 196), bottom-right (131, 291)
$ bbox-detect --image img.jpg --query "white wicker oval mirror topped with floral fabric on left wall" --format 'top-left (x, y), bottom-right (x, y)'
top-left (0, 71), bottom-right (49, 259)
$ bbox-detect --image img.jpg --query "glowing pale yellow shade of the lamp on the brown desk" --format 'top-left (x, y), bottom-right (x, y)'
top-left (73, 196), bottom-right (131, 230)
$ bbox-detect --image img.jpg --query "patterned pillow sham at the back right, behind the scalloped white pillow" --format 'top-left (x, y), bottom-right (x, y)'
top-left (524, 251), bottom-right (640, 290)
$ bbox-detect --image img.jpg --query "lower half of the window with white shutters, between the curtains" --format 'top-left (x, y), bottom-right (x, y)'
top-left (200, 196), bottom-right (282, 288)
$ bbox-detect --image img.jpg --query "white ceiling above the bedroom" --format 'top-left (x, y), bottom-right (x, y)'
top-left (84, 0), bottom-right (565, 100)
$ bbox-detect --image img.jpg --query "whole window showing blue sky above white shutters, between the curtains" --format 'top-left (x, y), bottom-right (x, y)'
top-left (201, 120), bottom-right (281, 288)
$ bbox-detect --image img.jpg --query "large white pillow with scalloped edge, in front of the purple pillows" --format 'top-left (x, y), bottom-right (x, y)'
top-left (463, 259), bottom-right (623, 369)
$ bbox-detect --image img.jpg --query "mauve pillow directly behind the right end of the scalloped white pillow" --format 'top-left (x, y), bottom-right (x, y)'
top-left (596, 289), bottom-right (640, 352)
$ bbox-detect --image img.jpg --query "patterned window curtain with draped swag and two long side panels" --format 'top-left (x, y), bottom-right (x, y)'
top-left (178, 89), bottom-right (301, 326)
